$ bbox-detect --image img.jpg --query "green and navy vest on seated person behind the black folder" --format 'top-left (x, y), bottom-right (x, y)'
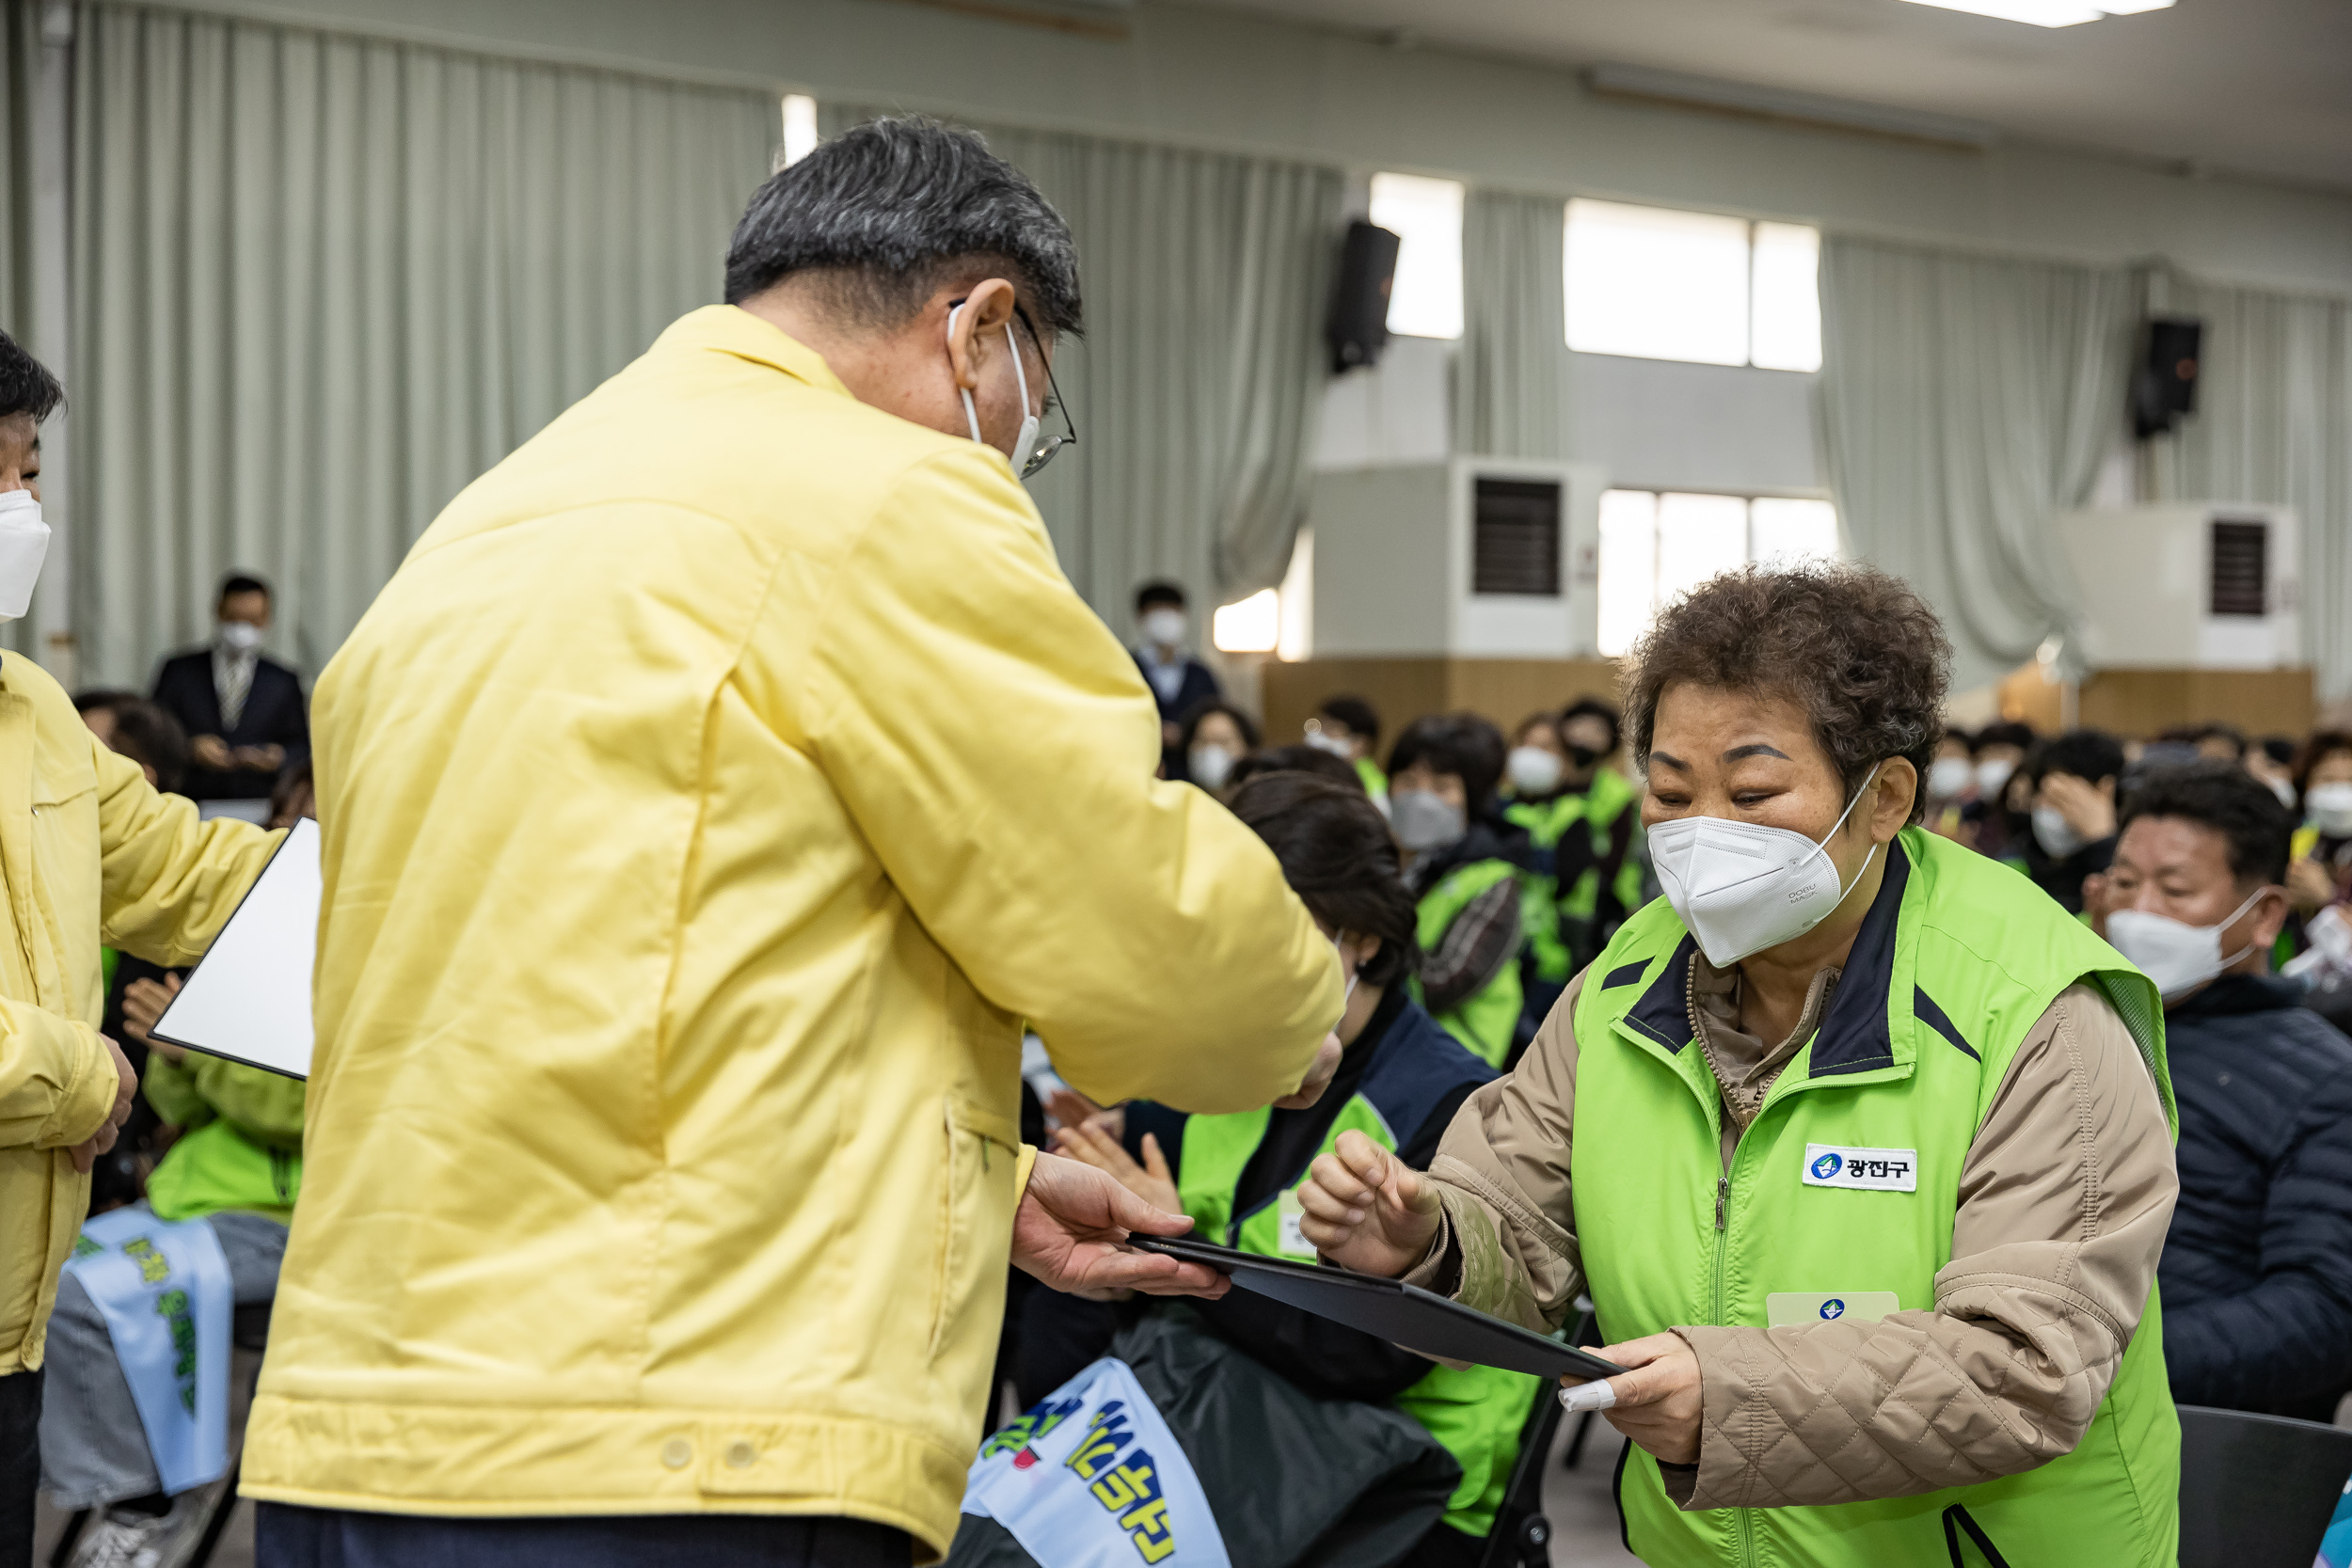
top-left (1176, 1006), bottom-right (1543, 1538)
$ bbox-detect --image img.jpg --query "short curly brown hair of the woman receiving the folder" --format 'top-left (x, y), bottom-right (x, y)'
top-left (1623, 562), bottom-right (1952, 823)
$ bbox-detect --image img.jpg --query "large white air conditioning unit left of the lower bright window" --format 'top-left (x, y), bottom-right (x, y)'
top-left (1308, 458), bottom-right (1607, 658)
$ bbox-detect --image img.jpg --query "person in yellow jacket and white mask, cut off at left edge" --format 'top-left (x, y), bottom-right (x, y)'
top-left (0, 334), bottom-right (280, 1568)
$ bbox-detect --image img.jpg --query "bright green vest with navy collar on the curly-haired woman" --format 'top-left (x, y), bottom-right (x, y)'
top-left (1569, 828), bottom-right (2181, 1568)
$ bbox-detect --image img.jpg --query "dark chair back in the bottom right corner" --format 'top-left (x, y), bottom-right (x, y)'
top-left (2181, 1406), bottom-right (2352, 1568)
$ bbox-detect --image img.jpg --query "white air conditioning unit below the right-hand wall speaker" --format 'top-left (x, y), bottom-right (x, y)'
top-left (2056, 500), bottom-right (2305, 670)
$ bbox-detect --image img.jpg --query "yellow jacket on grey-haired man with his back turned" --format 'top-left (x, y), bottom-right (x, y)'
top-left (245, 306), bottom-right (1341, 1549)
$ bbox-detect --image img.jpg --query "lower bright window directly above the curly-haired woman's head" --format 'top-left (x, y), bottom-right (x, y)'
top-left (1599, 489), bottom-right (1837, 658)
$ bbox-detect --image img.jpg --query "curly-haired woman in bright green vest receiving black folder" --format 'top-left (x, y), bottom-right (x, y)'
top-left (1301, 566), bottom-right (2181, 1568)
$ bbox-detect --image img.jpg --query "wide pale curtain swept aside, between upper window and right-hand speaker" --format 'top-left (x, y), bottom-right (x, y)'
top-left (1820, 235), bottom-right (2138, 689)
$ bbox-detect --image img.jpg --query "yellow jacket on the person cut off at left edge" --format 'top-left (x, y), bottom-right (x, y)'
top-left (0, 654), bottom-right (278, 1375)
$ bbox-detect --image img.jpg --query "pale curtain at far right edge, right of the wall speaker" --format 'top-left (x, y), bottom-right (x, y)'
top-left (2150, 273), bottom-right (2352, 701)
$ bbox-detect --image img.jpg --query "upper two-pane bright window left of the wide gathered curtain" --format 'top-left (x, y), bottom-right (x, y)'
top-left (1562, 198), bottom-right (1820, 372)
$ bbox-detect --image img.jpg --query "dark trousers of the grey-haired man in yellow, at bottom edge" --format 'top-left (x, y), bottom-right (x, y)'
top-left (254, 1502), bottom-right (915, 1568)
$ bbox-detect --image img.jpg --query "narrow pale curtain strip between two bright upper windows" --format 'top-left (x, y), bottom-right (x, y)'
top-left (1454, 190), bottom-right (1569, 458)
